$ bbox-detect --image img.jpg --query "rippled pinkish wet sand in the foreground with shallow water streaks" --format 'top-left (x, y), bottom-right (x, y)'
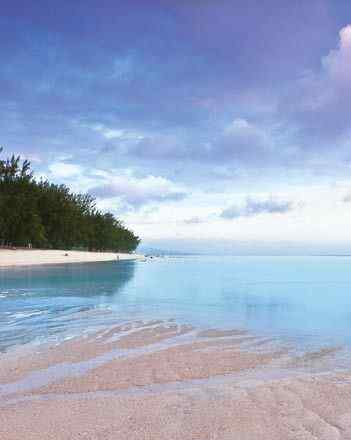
top-left (0, 321), bottom-right (351, 440)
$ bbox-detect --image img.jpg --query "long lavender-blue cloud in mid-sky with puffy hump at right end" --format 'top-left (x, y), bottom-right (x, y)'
top-left (104, 117), bottom-right (274, 166)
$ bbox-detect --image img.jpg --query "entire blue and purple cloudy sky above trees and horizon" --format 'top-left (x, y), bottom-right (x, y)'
top-left (0, 0), bottom-right (351, 252)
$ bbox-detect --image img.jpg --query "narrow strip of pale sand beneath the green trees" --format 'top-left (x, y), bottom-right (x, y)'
top-left (0, 249), bottom-right (144, 267)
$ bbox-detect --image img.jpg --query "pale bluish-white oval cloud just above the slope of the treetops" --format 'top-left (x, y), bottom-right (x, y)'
top-left (89, 175), bottom-right (187, 207)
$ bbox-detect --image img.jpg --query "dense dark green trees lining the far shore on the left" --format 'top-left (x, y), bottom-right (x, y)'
top-left (0, 148), bottom-right (140, 252)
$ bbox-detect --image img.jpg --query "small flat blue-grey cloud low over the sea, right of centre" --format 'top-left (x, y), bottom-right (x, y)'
top-left (220, 198), bottom-right (293, 219)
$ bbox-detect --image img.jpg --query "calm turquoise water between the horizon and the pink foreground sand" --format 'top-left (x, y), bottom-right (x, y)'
top-left (0, 257), bottom-right (351, 350)
